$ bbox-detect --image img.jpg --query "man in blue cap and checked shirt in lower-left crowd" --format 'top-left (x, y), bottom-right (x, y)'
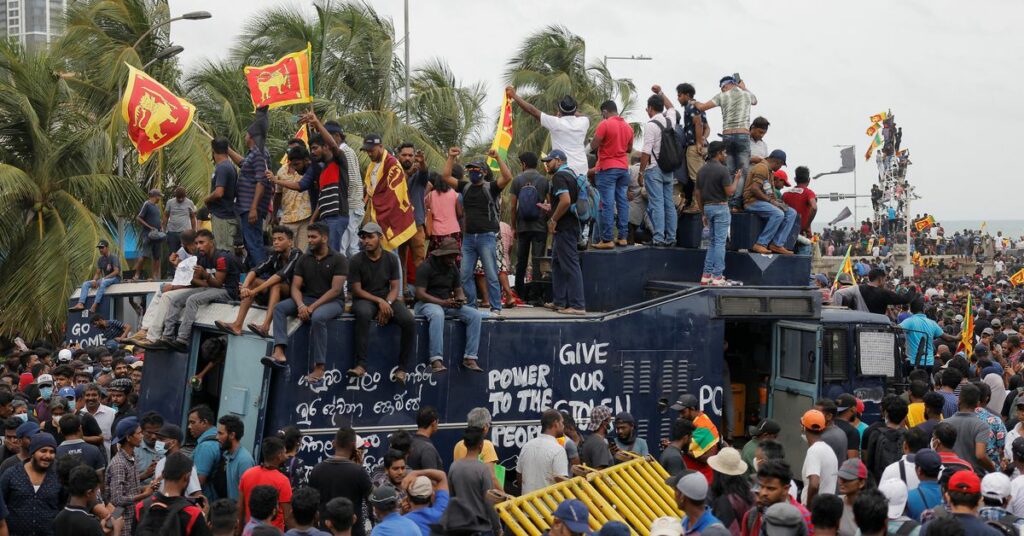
top-left (106, 417), bottom-right (157, 536)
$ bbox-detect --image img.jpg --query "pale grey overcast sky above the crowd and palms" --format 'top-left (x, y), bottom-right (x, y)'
top-left (169, 0), bottom-right (1024, 220)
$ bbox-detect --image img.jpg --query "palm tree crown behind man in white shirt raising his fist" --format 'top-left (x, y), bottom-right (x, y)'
top-left (505, 26), bottom-right (638, 157)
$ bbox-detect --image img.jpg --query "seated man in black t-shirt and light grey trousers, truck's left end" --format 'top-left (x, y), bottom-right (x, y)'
top-left (152, 229), bottom-right (241, 352)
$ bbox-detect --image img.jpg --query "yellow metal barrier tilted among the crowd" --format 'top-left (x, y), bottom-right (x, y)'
top-left (495, 453), bottom-right (683, 536)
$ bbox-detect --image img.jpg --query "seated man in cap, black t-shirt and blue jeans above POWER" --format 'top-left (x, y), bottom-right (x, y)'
top-left (415, 238), bottom-right (484, 373)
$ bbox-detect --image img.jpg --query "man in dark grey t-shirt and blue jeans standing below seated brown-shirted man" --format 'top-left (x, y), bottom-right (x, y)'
top-left (693, 141), bottom-right (740, 286)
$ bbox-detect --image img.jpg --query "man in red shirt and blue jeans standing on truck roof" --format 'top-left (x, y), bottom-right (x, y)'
top-left (590, 100), bottom-right (633, 249)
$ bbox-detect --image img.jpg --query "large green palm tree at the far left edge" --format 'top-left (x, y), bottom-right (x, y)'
top-left (0, 41), bottom-right (143, 339)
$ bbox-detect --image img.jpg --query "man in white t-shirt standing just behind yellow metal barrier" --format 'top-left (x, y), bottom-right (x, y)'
top-left (515, 409), bottom-right (569, 495)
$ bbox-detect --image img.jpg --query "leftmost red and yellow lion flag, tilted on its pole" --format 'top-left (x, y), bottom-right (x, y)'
top-left (121, 66), bottom-right (196, 164)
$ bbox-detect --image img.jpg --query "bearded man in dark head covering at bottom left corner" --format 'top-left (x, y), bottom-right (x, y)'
top-left (0, 432), bottom-right (61, 535)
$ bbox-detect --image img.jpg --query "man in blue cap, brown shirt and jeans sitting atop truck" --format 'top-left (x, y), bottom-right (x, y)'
top-left (743, 149), bottom-right (798, 255)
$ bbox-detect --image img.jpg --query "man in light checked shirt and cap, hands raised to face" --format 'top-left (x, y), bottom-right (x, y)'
top-left (695, 74), bottom-right (758, 209)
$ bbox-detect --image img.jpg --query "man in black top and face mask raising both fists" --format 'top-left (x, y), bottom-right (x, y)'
top-left (441, 147), bottom-right (512, 315)
